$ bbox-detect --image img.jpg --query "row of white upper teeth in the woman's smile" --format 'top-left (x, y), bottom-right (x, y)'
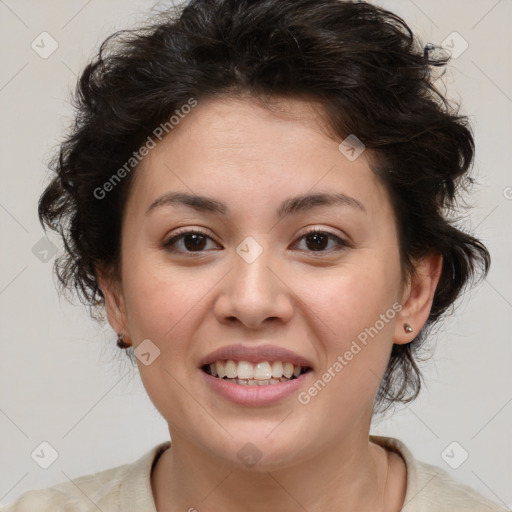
top-left (210, 359), bottom-right (302, 380)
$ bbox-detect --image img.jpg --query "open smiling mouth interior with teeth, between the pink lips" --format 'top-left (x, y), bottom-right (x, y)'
top-left (201, 359), bottom-right (311, 386)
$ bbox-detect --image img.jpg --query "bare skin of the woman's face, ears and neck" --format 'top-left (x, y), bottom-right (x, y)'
top-left (98, 98), bottom-right (441, 512)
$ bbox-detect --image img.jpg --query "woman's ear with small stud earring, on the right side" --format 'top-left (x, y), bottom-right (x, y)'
top-left (393, 252), bottom-right (443, 345)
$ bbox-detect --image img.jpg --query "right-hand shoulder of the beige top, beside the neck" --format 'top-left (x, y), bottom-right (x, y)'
top-left (370, 436), bottom-right (510, 512)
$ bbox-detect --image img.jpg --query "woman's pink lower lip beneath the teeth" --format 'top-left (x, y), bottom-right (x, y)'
top-left (199, 369), bottom-right (312, 407)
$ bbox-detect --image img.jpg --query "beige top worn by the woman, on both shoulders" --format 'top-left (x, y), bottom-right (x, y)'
top-left (1, 435), bottom-right (507, 512)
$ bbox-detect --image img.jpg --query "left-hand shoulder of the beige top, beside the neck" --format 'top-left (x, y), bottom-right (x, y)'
top-left (0, 442), bottom-right (169, 512)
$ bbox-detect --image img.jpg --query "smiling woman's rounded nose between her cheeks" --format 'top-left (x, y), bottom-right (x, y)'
top-left (213, 246), bottom-right (294, 329)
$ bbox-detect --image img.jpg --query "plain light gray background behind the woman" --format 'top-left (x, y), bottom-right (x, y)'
top-left (0, 0), bottom-right (512, 506)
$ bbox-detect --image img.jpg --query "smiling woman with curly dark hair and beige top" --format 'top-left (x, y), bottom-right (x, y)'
top-left (7, 0), bottom-right (504, 512)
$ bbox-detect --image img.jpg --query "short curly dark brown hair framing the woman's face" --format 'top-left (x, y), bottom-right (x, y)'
top-left (39, 0), bottom-right (490, 412)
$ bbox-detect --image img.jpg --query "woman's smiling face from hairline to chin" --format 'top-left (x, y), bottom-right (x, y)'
top-left (104, 99), bottom-right (436, 469)
